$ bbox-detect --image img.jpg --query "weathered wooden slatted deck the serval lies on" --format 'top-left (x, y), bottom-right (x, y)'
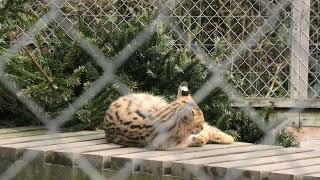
top-left (0, 127), bottom-right (320, 180)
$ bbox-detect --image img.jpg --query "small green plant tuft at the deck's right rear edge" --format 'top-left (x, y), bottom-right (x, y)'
top-left (275, 129), bottom-right (300, 147)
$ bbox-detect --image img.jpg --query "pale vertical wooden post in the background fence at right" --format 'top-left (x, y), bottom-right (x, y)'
top-left (290, 0), bottom-right (310, 99)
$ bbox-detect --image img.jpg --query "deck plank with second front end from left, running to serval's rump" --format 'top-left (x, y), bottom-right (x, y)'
top-left (23, 138), bottom-right (106, 163)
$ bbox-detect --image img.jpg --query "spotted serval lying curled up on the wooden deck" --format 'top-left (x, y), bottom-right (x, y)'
top-left (104, 83), bottom-right (233, 150)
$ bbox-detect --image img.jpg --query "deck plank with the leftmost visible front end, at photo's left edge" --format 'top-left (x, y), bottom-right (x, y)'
top-left (0, 133), bottom-right (104, 160)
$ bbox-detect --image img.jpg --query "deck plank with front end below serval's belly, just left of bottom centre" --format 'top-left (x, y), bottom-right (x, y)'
top-left (141, 145), bottom-right (281, 174)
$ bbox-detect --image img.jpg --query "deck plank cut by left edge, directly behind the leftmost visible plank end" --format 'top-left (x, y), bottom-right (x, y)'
top-left (0, 131), bottom-right (103, 145)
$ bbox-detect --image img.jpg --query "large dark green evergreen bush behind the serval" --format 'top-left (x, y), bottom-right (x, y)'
top-left (0, 2), bottom-right (263, 142)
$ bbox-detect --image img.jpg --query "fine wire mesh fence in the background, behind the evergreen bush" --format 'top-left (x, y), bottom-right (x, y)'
top-left (7, 0), bottom-right (319, 98)
